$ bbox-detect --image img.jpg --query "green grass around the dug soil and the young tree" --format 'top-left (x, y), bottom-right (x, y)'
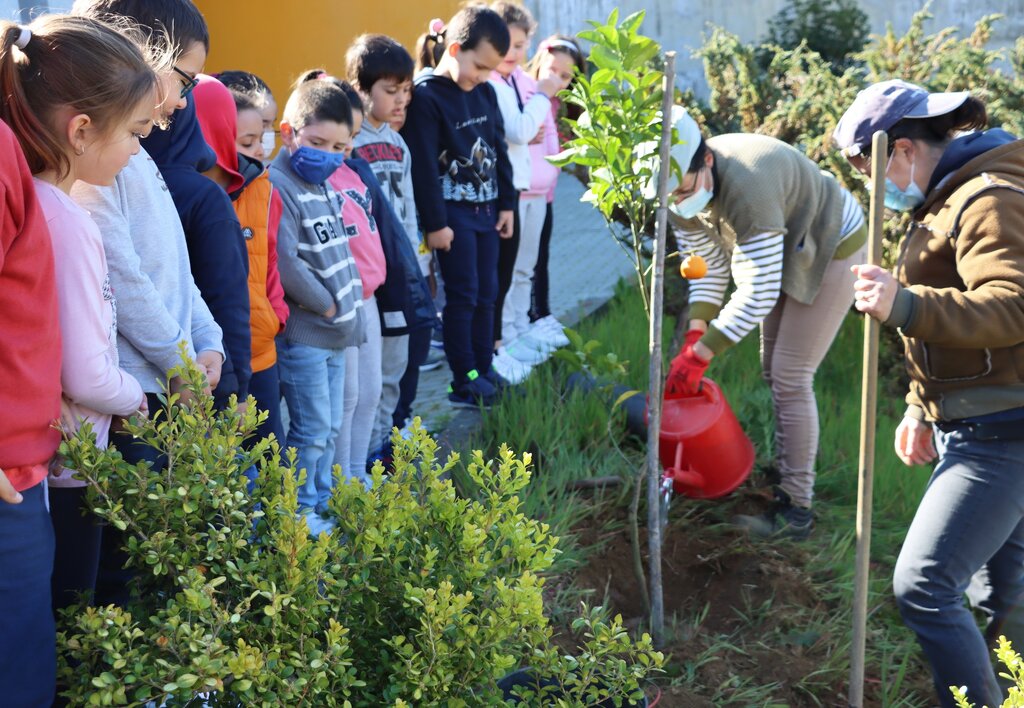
top-left (458, 285), bottom-right (932, 706)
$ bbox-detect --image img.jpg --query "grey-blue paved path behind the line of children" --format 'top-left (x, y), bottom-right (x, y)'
top-left (413, 173), bottom-right (634, 431)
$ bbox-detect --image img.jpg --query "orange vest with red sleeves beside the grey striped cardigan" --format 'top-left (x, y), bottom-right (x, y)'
top-left (234, 172), bottom-right (281, 373)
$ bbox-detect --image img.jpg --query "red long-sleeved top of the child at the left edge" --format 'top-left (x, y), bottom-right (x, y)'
top-left (0, 121), bottom-right (60, 491)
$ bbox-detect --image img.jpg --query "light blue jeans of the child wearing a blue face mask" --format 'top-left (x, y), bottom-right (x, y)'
top-left (278, 337), bottom-right (345, 511)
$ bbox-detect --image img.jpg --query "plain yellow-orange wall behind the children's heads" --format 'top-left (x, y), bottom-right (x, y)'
top-left (196, 0), bottom-right (459, 109)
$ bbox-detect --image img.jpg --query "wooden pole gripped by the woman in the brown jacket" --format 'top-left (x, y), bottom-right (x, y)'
top-left (850, 130), bottom-right (889, 708)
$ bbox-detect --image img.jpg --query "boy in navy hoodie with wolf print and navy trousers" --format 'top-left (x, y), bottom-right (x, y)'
top-left (401, 6), bottom-right (515, 407)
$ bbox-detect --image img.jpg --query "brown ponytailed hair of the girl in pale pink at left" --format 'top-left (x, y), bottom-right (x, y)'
top-left (0, 14), bottom-right (157, 179)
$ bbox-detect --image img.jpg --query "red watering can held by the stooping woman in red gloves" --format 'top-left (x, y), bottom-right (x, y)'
top-left (658, 378), bottom-right (754, 499)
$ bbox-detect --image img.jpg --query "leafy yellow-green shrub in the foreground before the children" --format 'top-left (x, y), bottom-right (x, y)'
top-left (59, 362), bottom-right (663, 706)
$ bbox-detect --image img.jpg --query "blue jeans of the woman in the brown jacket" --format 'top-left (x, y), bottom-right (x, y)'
top-left (893, 424), bottom-right (1024, 706)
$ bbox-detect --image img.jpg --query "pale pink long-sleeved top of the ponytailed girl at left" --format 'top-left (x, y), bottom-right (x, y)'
top-left (35, 179), bottom-right (142, 487)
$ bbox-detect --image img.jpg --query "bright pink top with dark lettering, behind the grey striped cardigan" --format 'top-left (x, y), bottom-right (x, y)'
top-left (328, 165), bottom-right (387, 300)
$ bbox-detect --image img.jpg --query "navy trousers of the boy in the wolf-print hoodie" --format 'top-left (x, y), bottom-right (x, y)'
top-left (436, 202), bottom-right (499, 383)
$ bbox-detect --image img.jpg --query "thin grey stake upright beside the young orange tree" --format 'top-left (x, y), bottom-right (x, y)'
top-left (647, 51), bottom-right (685, 647)
